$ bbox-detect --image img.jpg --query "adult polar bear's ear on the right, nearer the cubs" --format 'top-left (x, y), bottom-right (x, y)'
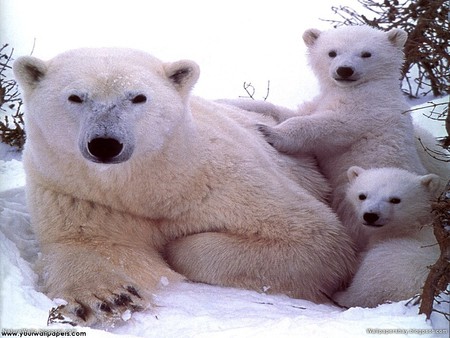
top-left (164, 60), bottom-right (200, 95)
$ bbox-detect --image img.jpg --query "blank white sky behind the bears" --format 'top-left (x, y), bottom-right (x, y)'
top-left (0, 0), bottom-right (361, 107)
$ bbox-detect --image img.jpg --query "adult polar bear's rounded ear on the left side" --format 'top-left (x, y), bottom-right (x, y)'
top-left (13, 56), bottom-right (47, 90)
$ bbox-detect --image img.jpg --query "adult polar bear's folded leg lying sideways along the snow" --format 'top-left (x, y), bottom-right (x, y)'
top-left (165, 232), bottom-right (354, 303)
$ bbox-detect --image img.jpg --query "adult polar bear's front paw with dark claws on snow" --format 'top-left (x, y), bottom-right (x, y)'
top-left (47, 285), bottom-right (149, 328)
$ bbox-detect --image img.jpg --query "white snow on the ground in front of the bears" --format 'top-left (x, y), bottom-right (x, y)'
top-left (0, 139), bottom-right (448, 338)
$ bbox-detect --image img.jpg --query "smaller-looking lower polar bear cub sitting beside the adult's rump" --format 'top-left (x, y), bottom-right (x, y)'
top-left (334, 167), bottom-right (439, 307)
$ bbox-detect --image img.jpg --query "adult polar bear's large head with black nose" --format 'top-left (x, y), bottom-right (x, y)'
top-left (13, 48), bottom-right (199, 164)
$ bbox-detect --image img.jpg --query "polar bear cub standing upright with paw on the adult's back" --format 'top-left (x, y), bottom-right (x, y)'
top-left (251, 26), bottom-right (427, 248)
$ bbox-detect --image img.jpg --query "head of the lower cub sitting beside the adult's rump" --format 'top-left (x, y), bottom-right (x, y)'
top-left (346, 167), bottom-right (439, 232)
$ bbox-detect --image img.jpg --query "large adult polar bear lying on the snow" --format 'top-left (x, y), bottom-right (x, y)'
top-left (14, 49), bottom-right (355, 325)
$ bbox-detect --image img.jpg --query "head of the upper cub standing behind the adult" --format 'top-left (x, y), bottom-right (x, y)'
top-left (303, 26), bottom-right (407, 88)
